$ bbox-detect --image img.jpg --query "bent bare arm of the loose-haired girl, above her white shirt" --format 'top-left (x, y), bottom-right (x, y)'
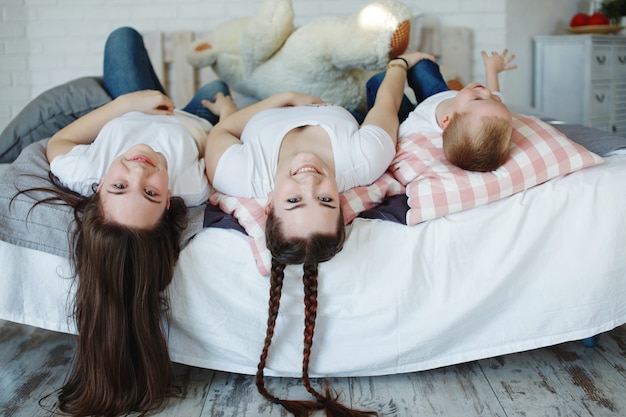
top-left (46, 90), bottom-right (174, 162)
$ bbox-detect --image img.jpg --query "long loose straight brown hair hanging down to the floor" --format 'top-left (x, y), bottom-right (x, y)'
top-left (22, 171), bottom-right (186, 416)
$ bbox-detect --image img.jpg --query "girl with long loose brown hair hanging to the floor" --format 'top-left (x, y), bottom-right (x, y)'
top-left (23, 27), bottom-right (236, 416)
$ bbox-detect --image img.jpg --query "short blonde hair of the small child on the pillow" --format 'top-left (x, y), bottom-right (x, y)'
top-left (443, 113), bottom-right (513, 172)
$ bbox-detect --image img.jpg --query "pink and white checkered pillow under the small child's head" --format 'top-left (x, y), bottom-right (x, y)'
top-left (390, 114), bottom-right (602, 225)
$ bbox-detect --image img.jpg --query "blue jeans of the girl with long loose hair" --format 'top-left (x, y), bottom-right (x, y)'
top-left (103, 27), bottom-right (230, 124)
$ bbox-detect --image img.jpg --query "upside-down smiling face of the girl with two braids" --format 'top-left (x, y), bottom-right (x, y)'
top-left (268, 153), bottom-right (340, 237)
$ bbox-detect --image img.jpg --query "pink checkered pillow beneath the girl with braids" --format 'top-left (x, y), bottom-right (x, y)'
top-left (209, 172), bottom-right (405, 275)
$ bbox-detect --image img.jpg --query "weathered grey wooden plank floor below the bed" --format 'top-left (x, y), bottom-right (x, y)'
top-left (0, 320), bottom-right (626, 417)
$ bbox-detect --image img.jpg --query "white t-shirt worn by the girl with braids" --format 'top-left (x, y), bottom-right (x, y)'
top-left (213, 104), bottom-right (396, 198)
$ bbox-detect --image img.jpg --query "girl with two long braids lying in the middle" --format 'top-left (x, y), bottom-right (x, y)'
top-left (205, 52), bottom-right (434, 416)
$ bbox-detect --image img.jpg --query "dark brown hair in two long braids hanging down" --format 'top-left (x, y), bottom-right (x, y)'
top-left (255, 210), bottom-right (377, 417)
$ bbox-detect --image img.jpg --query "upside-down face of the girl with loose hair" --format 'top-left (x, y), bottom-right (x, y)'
top-left (98, 145), bottom-right (171, 229)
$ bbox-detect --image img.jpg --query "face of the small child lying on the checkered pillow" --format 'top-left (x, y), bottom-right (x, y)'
top-left (452, 82), bottom-right (511, 120)
